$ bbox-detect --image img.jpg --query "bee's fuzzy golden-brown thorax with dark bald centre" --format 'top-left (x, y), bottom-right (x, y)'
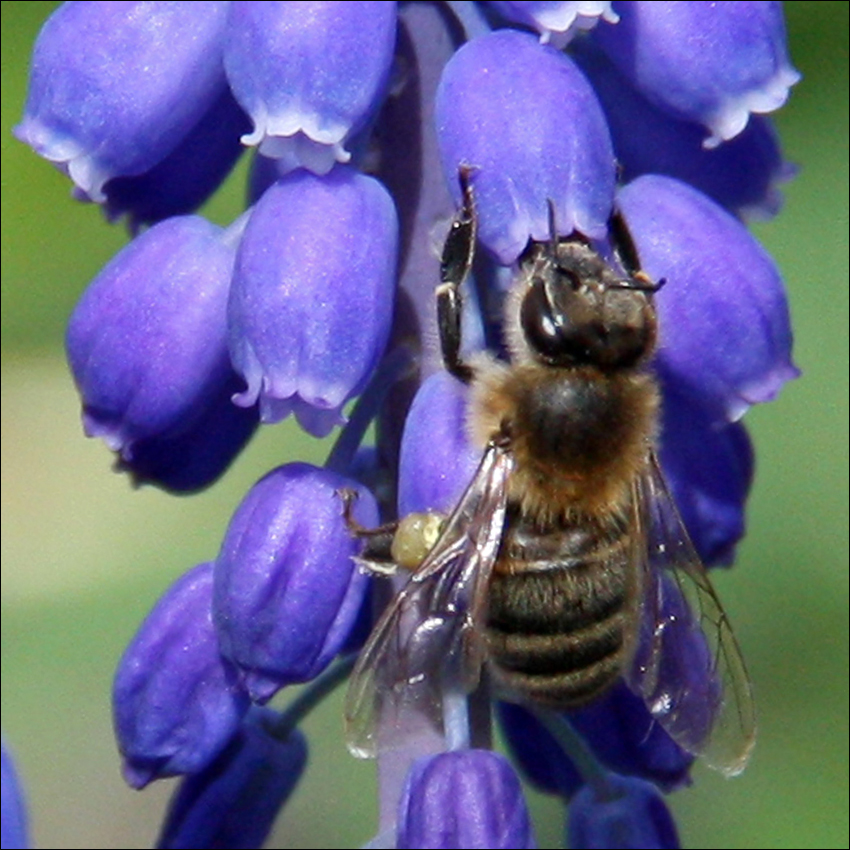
top-left (469, 358), bottom-right (659, 526)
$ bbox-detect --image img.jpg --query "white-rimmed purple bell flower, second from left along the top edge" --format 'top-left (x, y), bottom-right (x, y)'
top-left (224, 0), bottom-right (396, 174)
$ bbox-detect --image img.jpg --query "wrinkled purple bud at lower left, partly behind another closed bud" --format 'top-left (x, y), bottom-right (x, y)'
top-left (112, 564), bottom-right (249, 788)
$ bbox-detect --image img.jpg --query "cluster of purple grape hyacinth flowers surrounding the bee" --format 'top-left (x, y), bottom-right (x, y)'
top-left (9, 0), bottom-right (798, 848)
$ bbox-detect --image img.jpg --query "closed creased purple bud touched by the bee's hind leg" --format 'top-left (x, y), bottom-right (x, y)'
top-left (215, 463), bottom-right (378, 702)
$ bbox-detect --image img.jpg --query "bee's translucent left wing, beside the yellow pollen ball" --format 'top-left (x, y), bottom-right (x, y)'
top-left (345, 444), bottom-right (513, 757)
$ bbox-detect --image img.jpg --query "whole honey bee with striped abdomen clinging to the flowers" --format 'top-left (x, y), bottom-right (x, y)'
top-left (346, 169), bottom-right (755, 775)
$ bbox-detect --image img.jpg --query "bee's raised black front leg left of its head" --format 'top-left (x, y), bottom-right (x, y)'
top-left (437, 166), bottom-right (478, 383)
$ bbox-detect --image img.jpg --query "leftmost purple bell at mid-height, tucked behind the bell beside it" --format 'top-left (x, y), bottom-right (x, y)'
top-left (66, 216), bottom-right (253, 484)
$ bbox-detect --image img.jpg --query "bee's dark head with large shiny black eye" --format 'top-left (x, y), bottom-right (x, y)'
top-left (512, 238), bottom-right (657, 370)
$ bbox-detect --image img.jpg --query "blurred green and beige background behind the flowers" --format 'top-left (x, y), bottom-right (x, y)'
top-left (0, 2), bottom-right (850, 848)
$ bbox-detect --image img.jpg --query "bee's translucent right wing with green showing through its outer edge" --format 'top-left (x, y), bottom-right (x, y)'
top-left (629, 455), bottom-right (756, 776)
